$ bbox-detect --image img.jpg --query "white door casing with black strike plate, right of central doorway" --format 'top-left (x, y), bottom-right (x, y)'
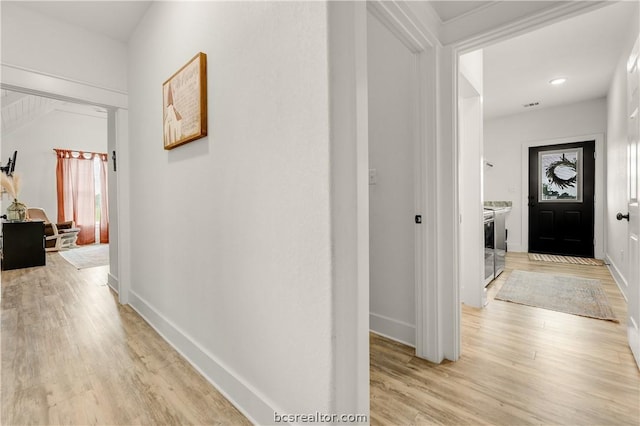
top-left (358, 1), bottom-right (442, 362)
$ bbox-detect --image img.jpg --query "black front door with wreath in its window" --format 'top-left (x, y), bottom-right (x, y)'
top-left (529, 141), bottom-right (595, 257)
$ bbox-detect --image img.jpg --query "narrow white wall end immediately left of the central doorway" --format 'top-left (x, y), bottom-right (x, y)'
top-left (327, 2), bottom-right (369, 415)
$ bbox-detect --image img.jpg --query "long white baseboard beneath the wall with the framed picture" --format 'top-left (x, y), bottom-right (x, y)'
top-left (129, 290), bottom-right (286, 424)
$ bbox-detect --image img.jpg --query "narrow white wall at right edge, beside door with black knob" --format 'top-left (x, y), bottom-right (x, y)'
top-left (605, 8), bottom-right (640, 297)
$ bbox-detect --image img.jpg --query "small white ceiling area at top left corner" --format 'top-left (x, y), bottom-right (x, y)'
top-left (20, 0), bottom-right (151, 43)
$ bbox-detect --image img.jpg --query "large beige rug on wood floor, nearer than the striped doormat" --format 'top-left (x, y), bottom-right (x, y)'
top-left (496, 270), bottom-right (618, 322)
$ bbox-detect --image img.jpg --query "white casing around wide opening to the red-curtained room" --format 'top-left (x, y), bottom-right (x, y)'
top-left (0, 64), bottom-right (131, 304)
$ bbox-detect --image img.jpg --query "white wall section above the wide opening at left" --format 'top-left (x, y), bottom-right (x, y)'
top-left (0, 1), bottom-right (127, 91)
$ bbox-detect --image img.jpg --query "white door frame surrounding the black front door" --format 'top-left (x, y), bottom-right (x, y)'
top-left (520, 133), bottom-right (605, 259)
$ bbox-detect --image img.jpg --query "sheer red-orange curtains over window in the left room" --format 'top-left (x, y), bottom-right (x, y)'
top-left (55, 149), bottom-right (109, 245)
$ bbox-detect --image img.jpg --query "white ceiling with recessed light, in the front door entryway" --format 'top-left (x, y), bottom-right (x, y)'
top-left (483, 1), bottom-right (637, 119)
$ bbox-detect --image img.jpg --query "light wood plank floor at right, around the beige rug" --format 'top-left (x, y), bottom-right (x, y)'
top-left (371, 253), bottom-right (640, 425)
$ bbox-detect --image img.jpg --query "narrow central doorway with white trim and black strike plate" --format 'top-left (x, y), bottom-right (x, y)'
top-left (358, 2), bottom-right (440, 360)
